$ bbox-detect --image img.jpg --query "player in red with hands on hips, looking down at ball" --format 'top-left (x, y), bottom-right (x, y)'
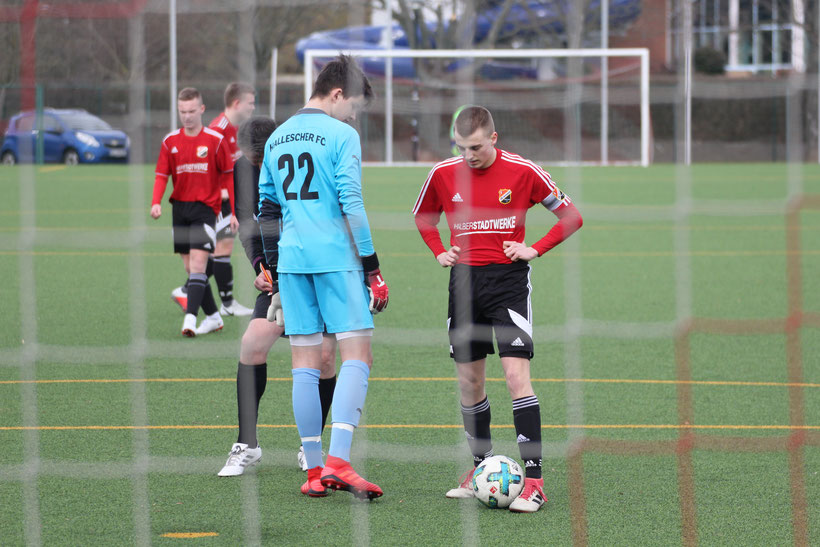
top-left (413, 106), bottom-right (583, 513)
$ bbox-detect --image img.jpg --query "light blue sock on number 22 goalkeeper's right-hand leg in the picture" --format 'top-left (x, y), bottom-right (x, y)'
top-left (328, 361), bottom-right (370, 462)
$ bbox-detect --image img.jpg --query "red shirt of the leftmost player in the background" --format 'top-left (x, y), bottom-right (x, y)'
top-left (151, 127), bottom-right (233, 214)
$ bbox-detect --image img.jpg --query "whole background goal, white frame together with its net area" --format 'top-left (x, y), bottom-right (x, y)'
top-left (304, 48), bottom-right (650, 165)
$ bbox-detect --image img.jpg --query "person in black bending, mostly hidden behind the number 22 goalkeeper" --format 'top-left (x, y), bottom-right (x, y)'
top-left (219, 116), bottom-right (336, 477)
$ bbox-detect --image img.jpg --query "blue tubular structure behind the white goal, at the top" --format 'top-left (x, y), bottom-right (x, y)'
top-left (296, 0), bottom-right (641, 80)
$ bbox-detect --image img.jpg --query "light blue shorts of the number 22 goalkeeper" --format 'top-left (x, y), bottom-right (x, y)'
top-left (279, 271), bottom-right (373, 334)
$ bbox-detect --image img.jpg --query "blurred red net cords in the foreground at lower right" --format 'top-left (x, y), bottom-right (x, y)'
top-left (568, 195), bottom-right (820, 546)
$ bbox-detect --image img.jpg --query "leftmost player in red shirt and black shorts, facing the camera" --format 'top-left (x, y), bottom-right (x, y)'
top-left (151, 87), bottom-right (233, 336)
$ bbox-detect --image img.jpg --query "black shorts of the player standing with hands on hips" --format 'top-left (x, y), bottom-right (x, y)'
top-left (447, 261), bottom-right (533, 363)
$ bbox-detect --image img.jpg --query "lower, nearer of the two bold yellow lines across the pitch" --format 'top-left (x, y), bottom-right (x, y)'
top-left (0, 424), bottom-right (820, 431)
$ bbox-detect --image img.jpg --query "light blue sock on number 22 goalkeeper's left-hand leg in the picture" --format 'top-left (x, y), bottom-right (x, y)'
top-left (291, 368), bottom-right (322, 469)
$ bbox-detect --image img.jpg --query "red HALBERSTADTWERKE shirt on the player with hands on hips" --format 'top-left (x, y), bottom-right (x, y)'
top-left (413, 149), bottom-right (574, 266)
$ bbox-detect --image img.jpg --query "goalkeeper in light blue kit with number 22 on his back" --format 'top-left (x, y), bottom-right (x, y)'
top-left (259, 55), bottom-right (388, 499)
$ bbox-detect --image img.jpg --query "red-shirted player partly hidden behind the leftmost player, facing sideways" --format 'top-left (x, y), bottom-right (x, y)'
top-left (171, 82), bottom-right (256, 316)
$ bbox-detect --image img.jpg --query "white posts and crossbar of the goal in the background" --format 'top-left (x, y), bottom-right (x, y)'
top-left (304, 48), bottom-right (651, 167)
